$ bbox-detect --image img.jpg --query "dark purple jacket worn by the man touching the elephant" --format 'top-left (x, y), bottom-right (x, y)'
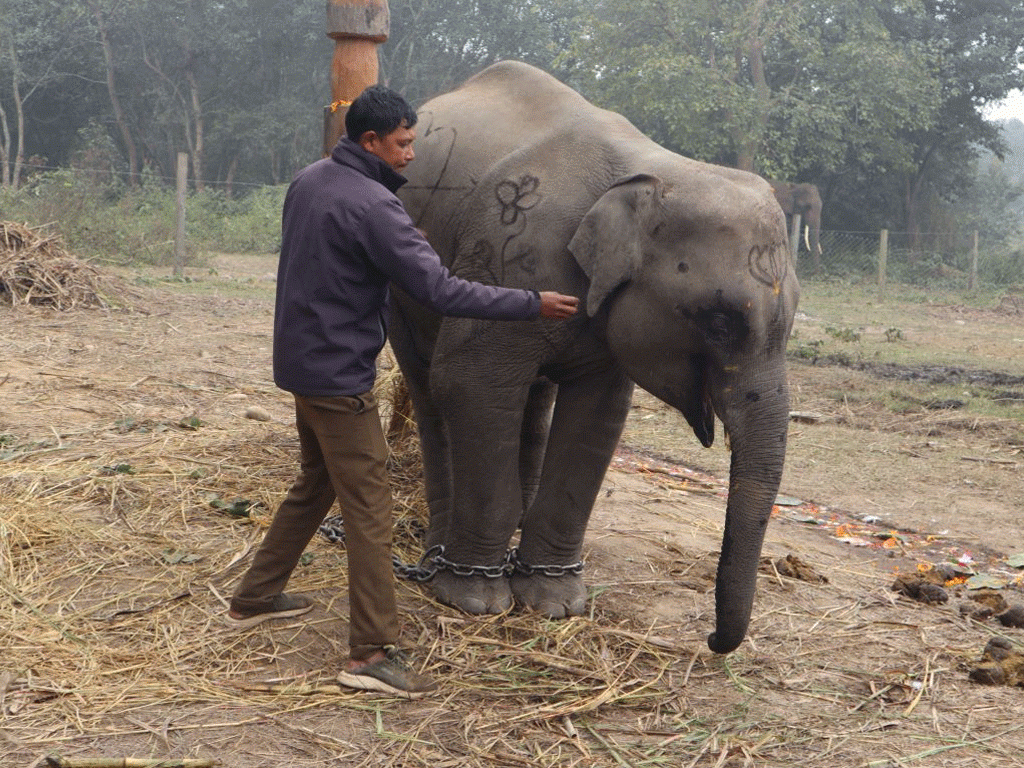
top-left (273, 138), bottom-right (541, 397)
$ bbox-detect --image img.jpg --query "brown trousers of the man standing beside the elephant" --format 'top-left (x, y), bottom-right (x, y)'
top-left (231, 392), bottom-right (398, 658)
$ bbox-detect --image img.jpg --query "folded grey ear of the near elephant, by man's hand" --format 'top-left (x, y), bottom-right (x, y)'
top-left (568, 173), bottom-right (663, 317)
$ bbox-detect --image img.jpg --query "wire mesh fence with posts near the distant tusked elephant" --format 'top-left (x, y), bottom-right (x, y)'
top-left (797, 230), bottom-right (1024, 298)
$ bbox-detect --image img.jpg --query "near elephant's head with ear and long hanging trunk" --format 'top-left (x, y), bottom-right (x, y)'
top-left (569, 169), bottom-right (799, 653)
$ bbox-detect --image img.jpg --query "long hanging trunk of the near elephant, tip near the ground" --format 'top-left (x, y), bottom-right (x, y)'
top-left (708, 372), bottom-right (790, 653)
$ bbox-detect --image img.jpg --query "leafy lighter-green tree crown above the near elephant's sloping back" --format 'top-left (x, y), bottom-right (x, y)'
top-left (569, 0), bottom-right (934, 180)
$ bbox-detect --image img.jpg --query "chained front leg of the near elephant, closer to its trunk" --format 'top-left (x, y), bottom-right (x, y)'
top-left (511, 366), bottom-right (633, 618)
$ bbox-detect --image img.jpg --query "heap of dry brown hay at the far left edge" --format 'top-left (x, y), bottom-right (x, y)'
top-left (0, 221), bottom-right (127, 309)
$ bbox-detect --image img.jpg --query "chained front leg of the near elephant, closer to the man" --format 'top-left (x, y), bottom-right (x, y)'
top-left (431, 362), bottom-right (534, 613)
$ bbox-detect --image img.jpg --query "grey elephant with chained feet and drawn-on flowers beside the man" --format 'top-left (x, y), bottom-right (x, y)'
top-left (391, 62), bottom-right (799, 653)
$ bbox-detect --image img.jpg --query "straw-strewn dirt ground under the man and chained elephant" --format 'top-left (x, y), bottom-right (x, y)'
top-left (0, 256), bottom-right (1024, 768)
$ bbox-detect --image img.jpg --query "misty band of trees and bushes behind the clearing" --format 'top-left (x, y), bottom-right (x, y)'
top-left (0, 0), bottom-right (1024, 282)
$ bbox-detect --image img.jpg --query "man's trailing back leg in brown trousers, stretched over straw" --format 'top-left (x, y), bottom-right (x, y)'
top-left (231, 396), bottom-right (335, 620)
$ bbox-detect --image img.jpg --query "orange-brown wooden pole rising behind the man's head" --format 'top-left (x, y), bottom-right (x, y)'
top-left (324, 0), bottom-right (391, 156)
